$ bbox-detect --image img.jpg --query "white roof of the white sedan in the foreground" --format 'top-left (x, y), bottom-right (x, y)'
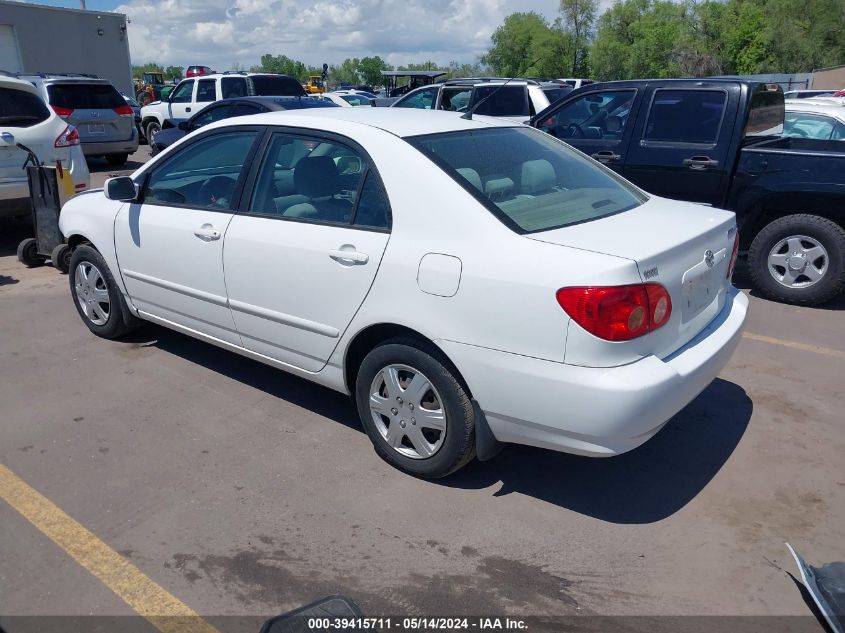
top-left (204, 107), bottom-right (521, 138)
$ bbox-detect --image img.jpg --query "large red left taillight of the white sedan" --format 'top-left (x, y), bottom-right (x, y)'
top-left (556, 283), bottom-right (672, 341)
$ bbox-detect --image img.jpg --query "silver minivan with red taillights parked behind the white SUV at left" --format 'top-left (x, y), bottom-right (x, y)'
top-left (18, 74), bottom-right (139, 166)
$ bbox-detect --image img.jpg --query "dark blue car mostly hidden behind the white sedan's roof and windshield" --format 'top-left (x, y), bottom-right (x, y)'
top-left (150, 97), bottom-right (337, 156)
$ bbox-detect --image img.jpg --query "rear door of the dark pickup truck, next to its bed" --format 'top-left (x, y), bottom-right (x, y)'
top-left (625, 83), bottom-right (739, 206)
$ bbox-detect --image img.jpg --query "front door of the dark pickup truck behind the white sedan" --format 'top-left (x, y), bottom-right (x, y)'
top-left (532, 88), bottom-right (639, 173)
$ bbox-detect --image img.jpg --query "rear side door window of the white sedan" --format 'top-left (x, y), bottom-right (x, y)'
top-left (244, 133), bottom-right (390, 228)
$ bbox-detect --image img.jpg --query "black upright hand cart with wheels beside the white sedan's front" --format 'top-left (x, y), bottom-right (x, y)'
top-left (17, 143), bottom-right (73, 273)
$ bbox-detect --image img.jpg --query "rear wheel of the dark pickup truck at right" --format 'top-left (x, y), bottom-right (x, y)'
top-left (748, 213), bottom-right (845, 306)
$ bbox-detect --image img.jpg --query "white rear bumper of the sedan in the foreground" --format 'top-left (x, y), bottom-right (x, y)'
top-left (437, 288), bottom-right (748, 457)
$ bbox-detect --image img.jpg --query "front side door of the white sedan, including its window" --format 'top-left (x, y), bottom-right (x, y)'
top-left (114, 128), bottom-right (260, 345)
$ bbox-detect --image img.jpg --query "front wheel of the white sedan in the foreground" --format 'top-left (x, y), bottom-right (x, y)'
top-left (68, 244), bottom-right (139, 339)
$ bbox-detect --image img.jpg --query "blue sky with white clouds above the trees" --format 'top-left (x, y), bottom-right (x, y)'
top-left (16, 0), bottom-right (584, 70)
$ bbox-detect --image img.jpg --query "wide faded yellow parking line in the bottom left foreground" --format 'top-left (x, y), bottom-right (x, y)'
top-left (0, 464), bottom-right (218, 633)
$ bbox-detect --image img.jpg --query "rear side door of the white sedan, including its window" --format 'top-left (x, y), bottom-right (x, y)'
top-left (223, 130), bottom-right (390, 372)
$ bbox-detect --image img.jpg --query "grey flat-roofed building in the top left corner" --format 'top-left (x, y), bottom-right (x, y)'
top-left (0, 0), bottom-right (135, 94)
